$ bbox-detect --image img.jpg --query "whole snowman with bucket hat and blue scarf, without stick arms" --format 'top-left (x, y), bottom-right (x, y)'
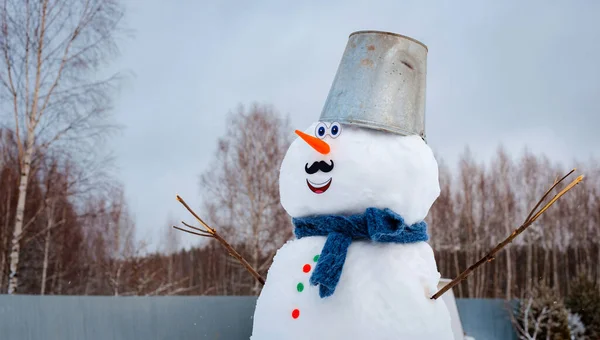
top-left (251, 31), bottom-right (453, 340)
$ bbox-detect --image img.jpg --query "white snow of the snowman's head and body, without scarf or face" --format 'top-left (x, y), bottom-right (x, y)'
top-left (251, 123), bottom-right (453, 340)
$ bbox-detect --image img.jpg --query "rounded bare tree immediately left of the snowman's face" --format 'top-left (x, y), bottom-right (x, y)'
top-left (201, 105), bottom-right (292, 293)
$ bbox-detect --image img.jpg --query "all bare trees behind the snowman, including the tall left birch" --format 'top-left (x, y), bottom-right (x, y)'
top-left (0, 0), bottom-right (600, 298)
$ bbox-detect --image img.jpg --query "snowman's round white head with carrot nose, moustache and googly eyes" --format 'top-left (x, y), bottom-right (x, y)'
top-left (279, 122), bottom-right (440, 224)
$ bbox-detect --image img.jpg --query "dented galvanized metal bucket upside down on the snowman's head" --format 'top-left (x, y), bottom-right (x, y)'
top-left (320, 31), bottom-right (427, 139)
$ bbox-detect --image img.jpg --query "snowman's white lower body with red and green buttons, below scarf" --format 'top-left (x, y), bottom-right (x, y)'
top-left (251, 237), bottom-right (453, 340)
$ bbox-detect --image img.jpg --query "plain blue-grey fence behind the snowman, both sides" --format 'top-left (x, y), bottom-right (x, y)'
top-left (0, 295), bottom-right (516, 340)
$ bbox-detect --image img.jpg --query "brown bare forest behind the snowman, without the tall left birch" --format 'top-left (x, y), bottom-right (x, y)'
top-left (0, 105), bottom-right (600, 298)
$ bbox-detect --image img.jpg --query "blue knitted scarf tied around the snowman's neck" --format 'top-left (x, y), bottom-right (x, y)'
top-left (292, 208), bottom-right (428, 298)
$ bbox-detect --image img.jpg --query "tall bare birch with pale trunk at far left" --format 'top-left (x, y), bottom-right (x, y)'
top-left (0, 0), bottom-right (123, 294)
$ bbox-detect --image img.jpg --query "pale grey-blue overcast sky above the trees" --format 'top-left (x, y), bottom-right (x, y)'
top-left (106, 0), bottom-right (600, 250)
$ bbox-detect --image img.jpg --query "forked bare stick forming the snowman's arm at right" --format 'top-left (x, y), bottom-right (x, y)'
top-left (431, 171), bottom-right (583, 300)
